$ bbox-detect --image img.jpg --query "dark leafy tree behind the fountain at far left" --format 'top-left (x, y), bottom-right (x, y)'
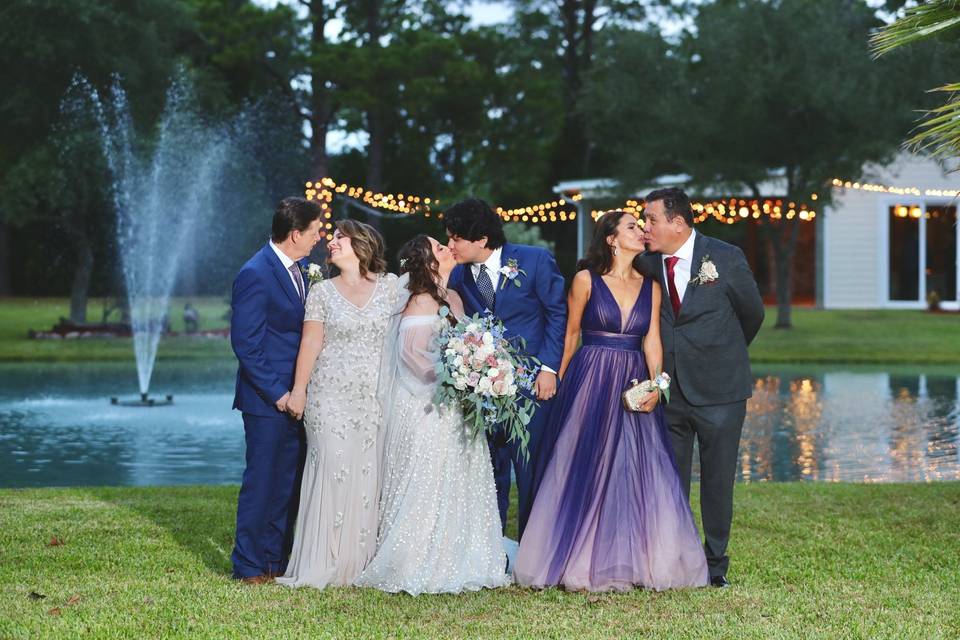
top-left (0, 0), bottom-right (189, 322)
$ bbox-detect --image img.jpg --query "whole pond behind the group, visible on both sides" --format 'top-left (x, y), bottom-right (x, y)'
top-left (0, 362), bottom-right (960, 487)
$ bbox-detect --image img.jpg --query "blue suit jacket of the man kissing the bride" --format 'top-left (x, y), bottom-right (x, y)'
top-left (449, 243), bottom-right (567, 371)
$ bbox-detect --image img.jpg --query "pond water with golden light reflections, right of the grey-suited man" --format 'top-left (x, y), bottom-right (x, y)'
top-left (738, 371), bottom-right (960, 482)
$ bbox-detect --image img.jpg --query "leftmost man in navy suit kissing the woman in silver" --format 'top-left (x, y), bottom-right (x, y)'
top-left (230, 198), bottom-right (323, 584)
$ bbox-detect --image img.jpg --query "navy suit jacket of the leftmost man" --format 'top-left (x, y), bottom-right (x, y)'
top-left (230, 243), bottom-right (309, 416)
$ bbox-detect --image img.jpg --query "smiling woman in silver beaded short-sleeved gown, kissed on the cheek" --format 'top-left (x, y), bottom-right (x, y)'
top-left (277, 220), bottom-right (397, 589)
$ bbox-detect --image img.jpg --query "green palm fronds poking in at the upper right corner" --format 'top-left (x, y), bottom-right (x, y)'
top-left (870, 0), bottom-right (960, 158)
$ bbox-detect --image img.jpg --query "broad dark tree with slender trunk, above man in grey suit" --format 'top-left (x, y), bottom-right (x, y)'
top-left (584, 0), bottom-right (949, 328)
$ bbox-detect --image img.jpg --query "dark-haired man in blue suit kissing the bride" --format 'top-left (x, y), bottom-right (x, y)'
top-left (443, 198), bottom-right (567, 537)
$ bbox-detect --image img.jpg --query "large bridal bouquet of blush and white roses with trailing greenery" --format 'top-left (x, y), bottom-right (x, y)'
top-left (434, 307), bottom-right (539, 458)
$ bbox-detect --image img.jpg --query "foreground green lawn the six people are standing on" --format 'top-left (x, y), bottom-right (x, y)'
top-left (0, 483), bottom-right (960, 639)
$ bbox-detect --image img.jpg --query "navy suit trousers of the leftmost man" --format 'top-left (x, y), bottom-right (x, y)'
top-left (231, 413), bottom-right (305, 578)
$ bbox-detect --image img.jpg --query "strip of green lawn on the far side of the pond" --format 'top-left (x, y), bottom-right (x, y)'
top-left (0, 298), bottom-right (960, 365)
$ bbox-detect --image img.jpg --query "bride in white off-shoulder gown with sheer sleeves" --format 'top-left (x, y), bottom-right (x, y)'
top-left (355, 235), bottom-right (510, 595)
